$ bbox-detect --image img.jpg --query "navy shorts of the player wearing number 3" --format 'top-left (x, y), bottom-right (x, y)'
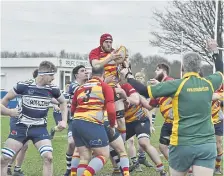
top-left (72, 119), bottom-right (109, 148)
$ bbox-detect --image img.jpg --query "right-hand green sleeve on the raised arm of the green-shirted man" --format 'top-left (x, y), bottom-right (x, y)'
top-left (205, 72), bottom-right (223, 91)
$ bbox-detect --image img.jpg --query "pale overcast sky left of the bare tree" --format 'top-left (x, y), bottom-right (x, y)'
top-left (1, 1), bottom-right (180, 60)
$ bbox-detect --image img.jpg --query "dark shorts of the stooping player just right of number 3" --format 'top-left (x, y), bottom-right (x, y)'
top-left (126, 118), bottom-right (150, 140)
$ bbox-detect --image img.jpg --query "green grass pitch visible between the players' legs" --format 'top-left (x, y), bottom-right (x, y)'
top-left (1, 109), bottom-right (222, 176)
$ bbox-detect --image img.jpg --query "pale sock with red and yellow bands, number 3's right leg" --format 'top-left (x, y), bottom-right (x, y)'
top-left (82, 156), bottom-right (106, 176)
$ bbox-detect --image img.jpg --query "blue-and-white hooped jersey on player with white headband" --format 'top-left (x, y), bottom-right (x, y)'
top-left (13, 79), bottom-right (61, 125)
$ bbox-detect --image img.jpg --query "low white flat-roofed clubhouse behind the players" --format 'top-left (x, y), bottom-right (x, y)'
top-left (0, 57), bottom-right (91, 91)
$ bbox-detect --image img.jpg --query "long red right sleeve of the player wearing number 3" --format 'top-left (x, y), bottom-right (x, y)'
top-left (102, 82), bottom-right (116, 127)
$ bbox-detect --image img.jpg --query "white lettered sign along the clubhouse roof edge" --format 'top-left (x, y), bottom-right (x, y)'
top-left (59, 58), bottom-right (90, 68)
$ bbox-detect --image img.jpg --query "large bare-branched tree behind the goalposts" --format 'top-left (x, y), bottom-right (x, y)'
top-left (150, 0), bottom-right (224, 64)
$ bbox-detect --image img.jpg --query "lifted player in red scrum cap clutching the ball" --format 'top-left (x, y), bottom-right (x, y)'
top-left (89, 34), bottom-right (126, 141)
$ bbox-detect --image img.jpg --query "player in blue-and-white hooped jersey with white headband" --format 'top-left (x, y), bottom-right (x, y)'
top-left (1, 61), bottom-right (67, 176)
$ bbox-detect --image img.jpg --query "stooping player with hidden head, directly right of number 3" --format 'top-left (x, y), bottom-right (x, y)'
top-left (121, 83), bottom-right (166, 176)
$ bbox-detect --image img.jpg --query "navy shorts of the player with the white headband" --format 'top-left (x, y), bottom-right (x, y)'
top-left (8, 121), bottom-right (49, 144)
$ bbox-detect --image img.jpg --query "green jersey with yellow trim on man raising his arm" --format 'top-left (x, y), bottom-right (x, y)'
top-left (148, 72), bottom-right (223, 145)
